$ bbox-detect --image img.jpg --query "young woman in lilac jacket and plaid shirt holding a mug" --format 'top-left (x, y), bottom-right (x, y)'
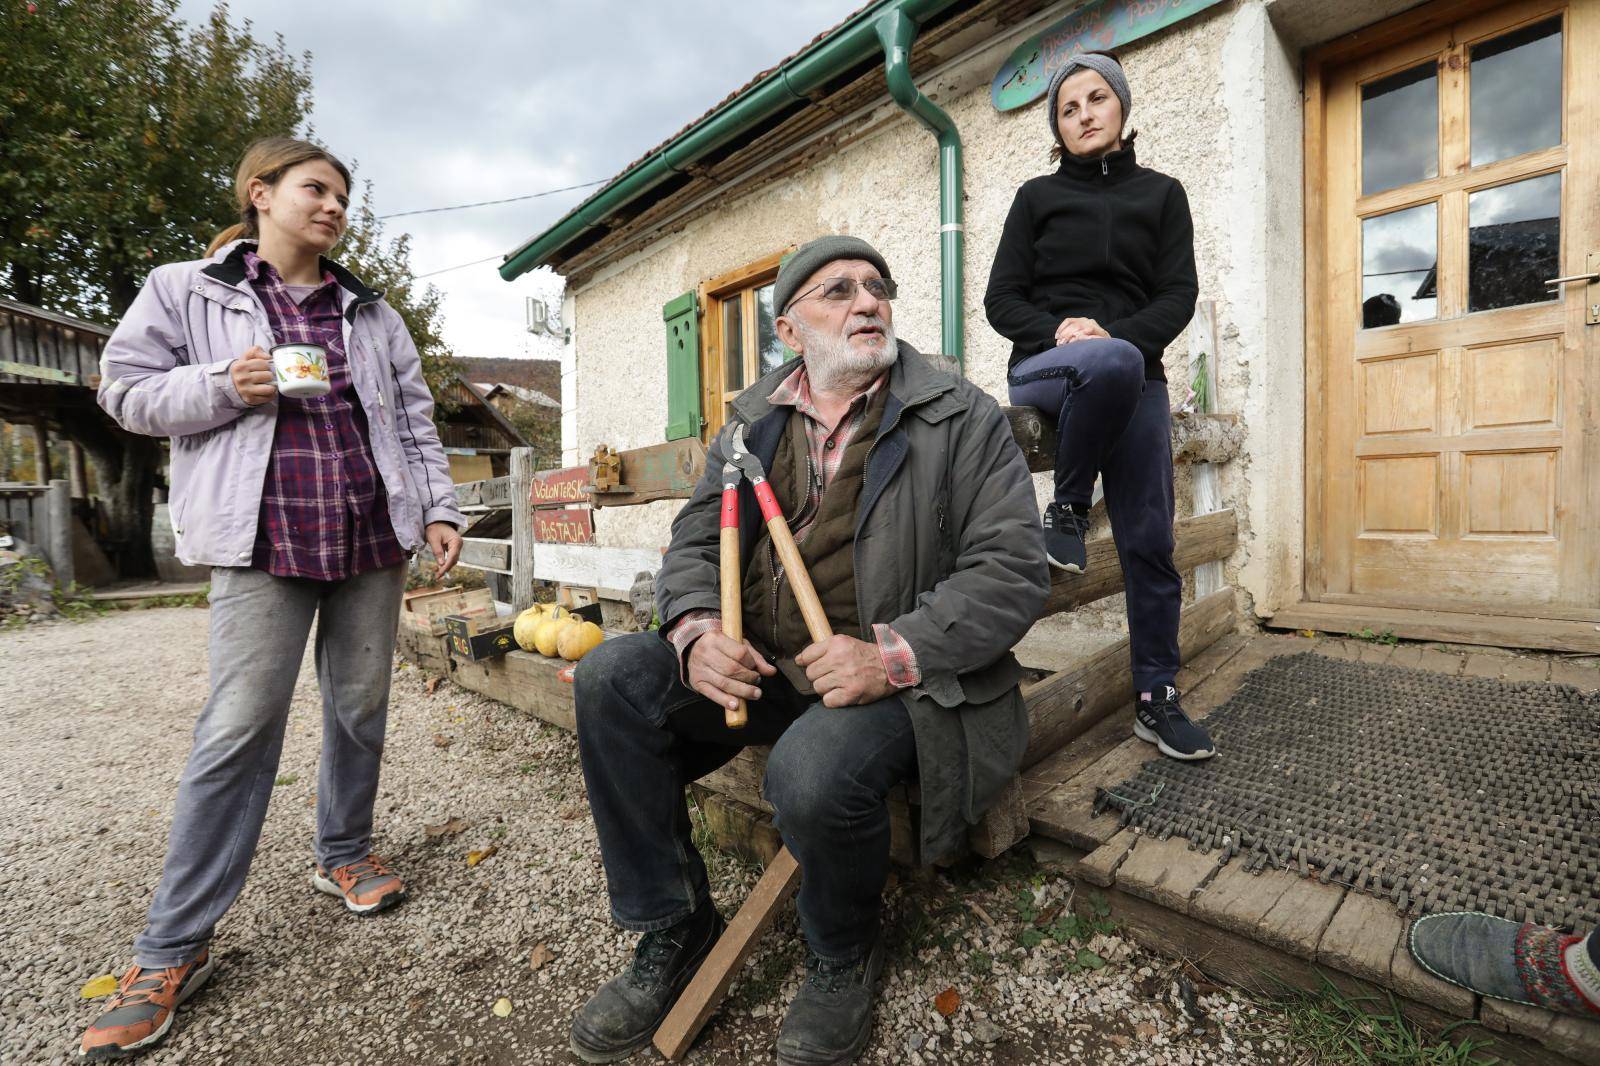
top-left (80, 138), bottom-right (462, 1058)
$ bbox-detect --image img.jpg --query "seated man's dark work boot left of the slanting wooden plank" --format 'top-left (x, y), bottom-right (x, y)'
top-left (570, 903), bottom-right (728, 1063)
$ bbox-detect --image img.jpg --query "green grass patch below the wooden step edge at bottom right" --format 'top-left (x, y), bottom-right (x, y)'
top-left (1262, 981), bottom-right (1501, 1066)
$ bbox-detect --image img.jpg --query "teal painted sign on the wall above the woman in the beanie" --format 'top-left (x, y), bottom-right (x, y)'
top-left (989, 0), bottom-right (1221, 110)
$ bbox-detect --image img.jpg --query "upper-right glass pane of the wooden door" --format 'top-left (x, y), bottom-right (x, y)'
top-left (1472, 18), bottom-right (1562, 166)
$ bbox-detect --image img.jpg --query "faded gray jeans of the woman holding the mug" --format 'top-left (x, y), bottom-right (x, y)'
top-left (133, 565), bottom-right (406, 968)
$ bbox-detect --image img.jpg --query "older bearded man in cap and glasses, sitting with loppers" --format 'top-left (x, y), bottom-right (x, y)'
top-left (571, 237), bottom-right (1050, 1066)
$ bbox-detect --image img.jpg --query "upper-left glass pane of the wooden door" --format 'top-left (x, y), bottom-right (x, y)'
top-left (1362, 59), bottom-right (1438, 195)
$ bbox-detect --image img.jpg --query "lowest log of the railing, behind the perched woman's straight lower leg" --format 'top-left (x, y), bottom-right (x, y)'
top-left (1022, 589), bottom-right (1234, 767)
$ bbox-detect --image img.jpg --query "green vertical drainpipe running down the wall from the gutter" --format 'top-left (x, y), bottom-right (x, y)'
top-left (877, 6), bottom-right (966, 370)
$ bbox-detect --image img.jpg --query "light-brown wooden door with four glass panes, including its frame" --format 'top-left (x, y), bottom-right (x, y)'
top-left (1307, 0), bottom-right (1600, 619)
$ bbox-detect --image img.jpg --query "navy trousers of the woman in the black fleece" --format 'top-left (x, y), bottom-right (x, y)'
top-left (1008, 338), bottom-right (1182, 691)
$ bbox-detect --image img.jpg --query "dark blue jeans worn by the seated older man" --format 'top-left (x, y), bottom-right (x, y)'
top-left (574, 634), bottom-right (917, 959)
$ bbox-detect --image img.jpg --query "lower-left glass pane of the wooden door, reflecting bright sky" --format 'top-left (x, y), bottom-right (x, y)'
top-left (1362, 203), bottom-right (1438, 330)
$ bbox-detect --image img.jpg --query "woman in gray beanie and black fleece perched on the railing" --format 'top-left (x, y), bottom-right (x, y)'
top-left (984, 53), bottom-right (1216, 759)
